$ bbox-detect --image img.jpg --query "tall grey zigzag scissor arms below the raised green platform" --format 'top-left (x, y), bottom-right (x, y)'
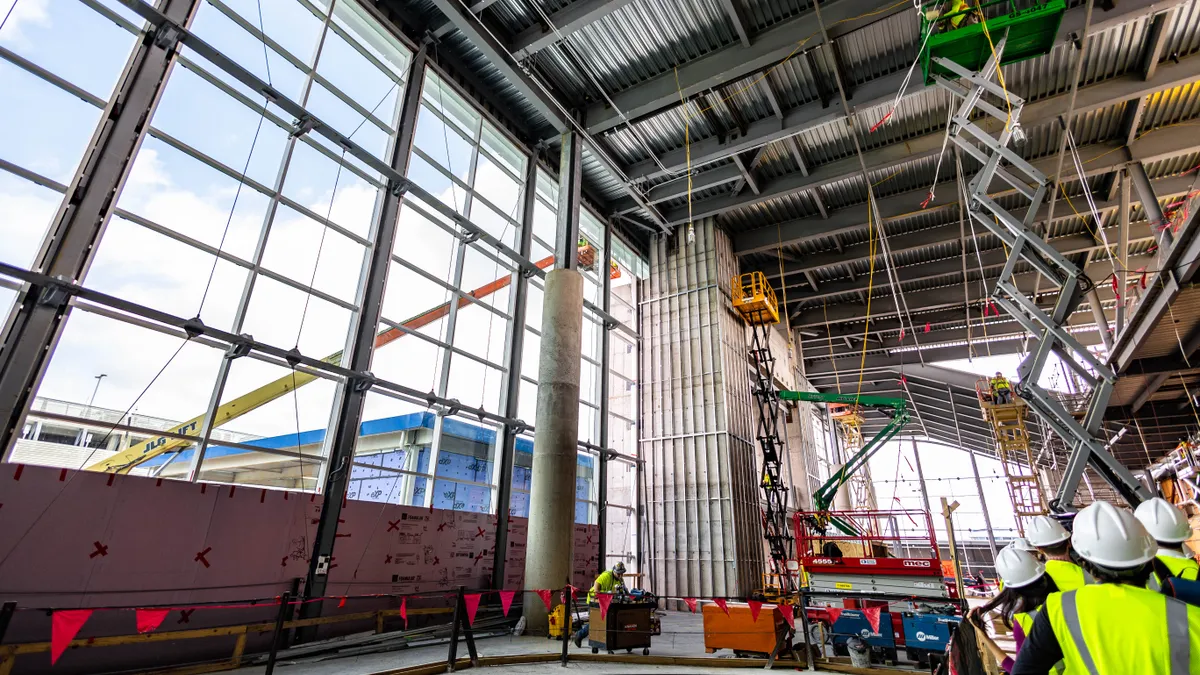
top-left (934, 37), bottom-right (1151, 513)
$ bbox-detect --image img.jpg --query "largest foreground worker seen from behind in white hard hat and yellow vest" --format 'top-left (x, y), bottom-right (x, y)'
top-left (1012, 502), bottom-right (1200, 675)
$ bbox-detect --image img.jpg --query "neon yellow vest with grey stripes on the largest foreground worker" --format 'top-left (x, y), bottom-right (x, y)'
top-left (1044, 584), bottom-right (1200, 675)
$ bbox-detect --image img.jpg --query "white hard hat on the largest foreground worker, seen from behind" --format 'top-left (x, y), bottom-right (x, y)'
top-left (1070, 502), bottom-right (1158, 569)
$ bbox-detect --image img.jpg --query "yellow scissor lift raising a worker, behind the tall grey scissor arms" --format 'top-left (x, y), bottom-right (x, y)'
top-left (976, 377), bottom-right (1049, 537)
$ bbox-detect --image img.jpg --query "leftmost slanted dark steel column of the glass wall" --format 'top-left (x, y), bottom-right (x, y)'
top-left (0, 0), bottom-right (199, 456)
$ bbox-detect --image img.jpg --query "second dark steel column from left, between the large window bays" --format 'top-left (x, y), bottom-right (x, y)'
top-left (300, 44), bottom-right (429, 619)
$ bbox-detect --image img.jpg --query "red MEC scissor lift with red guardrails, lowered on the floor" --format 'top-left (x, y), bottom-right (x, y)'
top-left (793, 509), bottom-right (961, 658)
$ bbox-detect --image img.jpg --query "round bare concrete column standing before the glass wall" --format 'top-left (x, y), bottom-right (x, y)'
top-left (524, 269), bottom-right (583, 634)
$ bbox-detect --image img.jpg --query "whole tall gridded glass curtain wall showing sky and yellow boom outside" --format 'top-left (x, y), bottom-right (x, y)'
top-left (0, 0), bottom-right (646, 535)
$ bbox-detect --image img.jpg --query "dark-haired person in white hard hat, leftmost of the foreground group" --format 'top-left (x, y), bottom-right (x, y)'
top-left (967, 545), bottom-right (1058, 673)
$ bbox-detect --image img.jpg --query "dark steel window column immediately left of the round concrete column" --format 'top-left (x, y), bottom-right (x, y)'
top-left (492, 152), bottom-right (538, 589)
